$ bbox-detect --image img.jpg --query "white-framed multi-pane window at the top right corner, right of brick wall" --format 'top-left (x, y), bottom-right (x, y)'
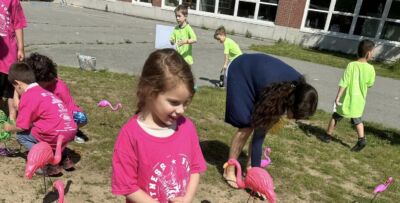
top-left (303, 0), bottom-right (400, 42)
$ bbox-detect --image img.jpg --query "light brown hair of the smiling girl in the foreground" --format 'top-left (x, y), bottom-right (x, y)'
top-left (136, 49), bottom-right (195, 113)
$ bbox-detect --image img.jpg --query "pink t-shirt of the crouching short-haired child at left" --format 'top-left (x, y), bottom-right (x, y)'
top-left (16, 83), bottom-right (77, 149)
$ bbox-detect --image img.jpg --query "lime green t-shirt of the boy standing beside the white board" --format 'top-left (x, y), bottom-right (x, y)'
top-left (171, 24), bottom-right (197, 65)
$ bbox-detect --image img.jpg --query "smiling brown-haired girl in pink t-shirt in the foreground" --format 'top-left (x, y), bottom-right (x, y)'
top-left (112, 49), bottom-right (207, 203)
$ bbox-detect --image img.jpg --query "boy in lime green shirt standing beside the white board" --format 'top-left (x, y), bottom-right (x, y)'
top-left (170, 5), bottom-right (197, 65)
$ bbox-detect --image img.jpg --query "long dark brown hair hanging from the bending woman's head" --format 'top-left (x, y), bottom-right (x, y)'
top-left (252, 77), bottom-right (318, 129)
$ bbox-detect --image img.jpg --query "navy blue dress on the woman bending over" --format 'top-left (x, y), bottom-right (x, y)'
top-left (225, 53), bottom-right (301, 128)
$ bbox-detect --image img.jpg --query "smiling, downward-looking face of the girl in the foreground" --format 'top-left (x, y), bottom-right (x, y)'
top-left (151, 83), bottom-right (191, 127)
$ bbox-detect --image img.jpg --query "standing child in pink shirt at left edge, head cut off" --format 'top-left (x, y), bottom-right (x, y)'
top-left (0, 0), bottom-right (26, 121)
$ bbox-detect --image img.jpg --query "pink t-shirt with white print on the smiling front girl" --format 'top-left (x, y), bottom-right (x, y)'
top-left (112, 115), bottom-right (207, 203)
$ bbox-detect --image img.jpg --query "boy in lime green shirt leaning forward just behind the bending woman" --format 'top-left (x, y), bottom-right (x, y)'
top-left (214, 26), bottom-right (242, 87)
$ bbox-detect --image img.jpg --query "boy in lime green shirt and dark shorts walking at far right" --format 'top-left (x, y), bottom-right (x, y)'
top-left (322, 40), bottom-right (375, 152)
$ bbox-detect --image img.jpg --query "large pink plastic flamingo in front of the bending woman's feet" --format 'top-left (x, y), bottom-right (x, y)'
top-left (224, 159), bottom-right (276, 203)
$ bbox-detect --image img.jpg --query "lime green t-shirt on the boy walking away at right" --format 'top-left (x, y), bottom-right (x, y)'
top-left (337, 61), bottom-right (375, 118)
